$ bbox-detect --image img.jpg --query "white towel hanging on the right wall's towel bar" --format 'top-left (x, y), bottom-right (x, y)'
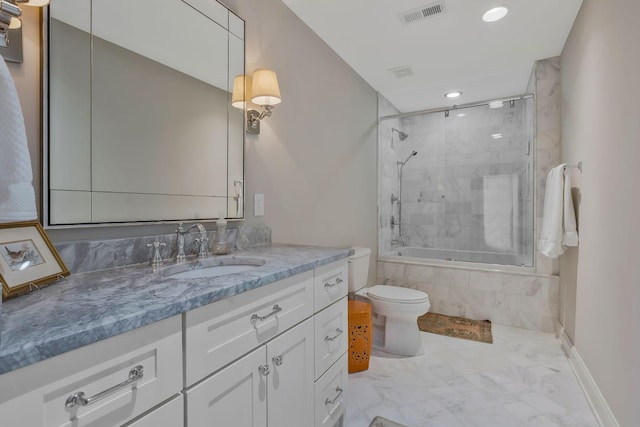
top-left (538, 163), bottom-right (578, 258)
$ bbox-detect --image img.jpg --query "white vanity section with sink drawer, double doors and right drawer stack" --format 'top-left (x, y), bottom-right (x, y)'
top-left (185, 260), bottom-right (348, 427)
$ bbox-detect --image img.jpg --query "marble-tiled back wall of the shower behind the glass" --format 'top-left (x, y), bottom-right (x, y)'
top-left (401, 101), bottom-right (532, 253)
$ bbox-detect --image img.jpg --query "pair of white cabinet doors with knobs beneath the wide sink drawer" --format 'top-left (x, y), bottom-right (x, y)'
top-left (186, 319), bottom-right (314, 427)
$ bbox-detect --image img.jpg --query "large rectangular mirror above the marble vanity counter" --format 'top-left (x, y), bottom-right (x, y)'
top-left (43, 0), bottom-right (244, 227)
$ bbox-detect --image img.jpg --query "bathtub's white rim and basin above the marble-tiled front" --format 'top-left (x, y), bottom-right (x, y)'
top-left (380, 247), bottom-right (533, 271)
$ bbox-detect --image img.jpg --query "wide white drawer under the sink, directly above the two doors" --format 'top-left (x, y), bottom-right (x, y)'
top-left (185, 271), bottom-right (313, 386)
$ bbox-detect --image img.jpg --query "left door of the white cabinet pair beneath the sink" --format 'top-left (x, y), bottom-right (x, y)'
top-left (186, 346), bottom-right (267, 427)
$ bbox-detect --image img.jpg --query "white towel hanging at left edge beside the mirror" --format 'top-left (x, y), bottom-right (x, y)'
top-left (0, 55), bottom-right (38, 222)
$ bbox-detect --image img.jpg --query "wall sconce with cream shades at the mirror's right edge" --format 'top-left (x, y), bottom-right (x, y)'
top-left (231, 68), bottom-right (282, 134)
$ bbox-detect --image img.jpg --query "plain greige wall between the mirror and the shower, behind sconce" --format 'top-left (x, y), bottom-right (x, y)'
top-left (226, 0), bottom-right (377, 281)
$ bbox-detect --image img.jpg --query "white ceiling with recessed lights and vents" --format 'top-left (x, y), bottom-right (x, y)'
top-left (283, 0), bottom-right (582, 112)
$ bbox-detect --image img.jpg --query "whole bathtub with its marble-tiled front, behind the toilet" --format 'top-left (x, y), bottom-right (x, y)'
top-left (377, 247), bottom-right (560, 332)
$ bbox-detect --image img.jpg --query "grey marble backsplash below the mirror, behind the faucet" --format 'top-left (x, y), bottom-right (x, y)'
top-left (55, 227), bottom-right (271, 273)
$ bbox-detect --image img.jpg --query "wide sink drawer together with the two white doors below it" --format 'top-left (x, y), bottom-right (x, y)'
top-left (185, 271), bottom-right (314, 427)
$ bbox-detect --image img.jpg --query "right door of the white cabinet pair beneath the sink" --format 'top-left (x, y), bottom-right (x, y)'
top-left (267, 319), bottom-right (314, 427)
